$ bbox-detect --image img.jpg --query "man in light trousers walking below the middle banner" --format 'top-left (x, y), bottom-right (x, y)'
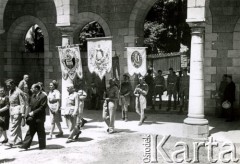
top-left (102, 79), bottom-right (119, 134)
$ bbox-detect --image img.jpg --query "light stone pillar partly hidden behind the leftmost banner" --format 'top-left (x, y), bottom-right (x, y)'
top-left (60, 27), bottom-right (73, 108)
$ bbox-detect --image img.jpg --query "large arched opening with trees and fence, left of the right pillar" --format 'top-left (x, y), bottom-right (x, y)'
top-left (127, 0), bottom-right (191, 111)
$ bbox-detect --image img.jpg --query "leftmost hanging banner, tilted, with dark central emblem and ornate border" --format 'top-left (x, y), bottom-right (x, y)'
top-left (58, 45), bottom-right (82, 80)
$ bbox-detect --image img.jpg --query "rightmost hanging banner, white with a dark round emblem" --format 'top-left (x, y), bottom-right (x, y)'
top-left (126, 47), bottom-right (147, 76)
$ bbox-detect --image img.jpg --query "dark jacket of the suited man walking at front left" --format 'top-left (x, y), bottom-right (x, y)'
top-left (30, 92), bottom-right (47, 122)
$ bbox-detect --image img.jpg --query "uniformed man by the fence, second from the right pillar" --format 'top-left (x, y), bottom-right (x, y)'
top-left (167, 68), bottom-right (177, 111)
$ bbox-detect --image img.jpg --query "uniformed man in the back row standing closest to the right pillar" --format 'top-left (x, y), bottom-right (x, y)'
top-left (179, 69), bottom-right (189, 113)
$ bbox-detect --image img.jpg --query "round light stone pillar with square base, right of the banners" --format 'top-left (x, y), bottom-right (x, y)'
top-left (184, 23), bottom-right (209, 138)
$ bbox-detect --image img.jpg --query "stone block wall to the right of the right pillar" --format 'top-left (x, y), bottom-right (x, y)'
top-left (204, 0), bottom-right (240, 114)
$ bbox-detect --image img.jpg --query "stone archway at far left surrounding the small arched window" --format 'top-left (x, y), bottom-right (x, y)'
top-left (4, 16), bottom-right (52, 82)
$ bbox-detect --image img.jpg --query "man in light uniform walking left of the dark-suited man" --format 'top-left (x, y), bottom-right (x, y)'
top-left (5, 79), bottom-right (25, 147)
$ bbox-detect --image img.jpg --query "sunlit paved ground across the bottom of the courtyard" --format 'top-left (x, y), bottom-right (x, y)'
top-left (0, 110), bottom-right (240, 164)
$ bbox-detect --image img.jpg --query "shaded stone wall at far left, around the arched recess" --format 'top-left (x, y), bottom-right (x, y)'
top-left (0, 0), bottom-right (61, 91)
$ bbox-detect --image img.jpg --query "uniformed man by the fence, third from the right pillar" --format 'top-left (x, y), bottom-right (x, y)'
top-left (154, 70), bottom-right (166, 109)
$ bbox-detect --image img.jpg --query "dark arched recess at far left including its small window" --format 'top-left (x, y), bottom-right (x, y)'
top-left (5, 16), bottom-right (49, 84)
